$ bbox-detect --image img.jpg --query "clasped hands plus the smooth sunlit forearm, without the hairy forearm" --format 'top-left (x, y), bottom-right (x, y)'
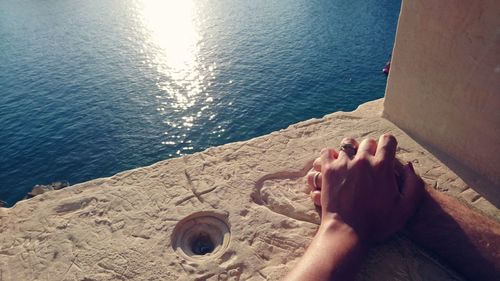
top-left (285, 134), bottom-right (424, 280)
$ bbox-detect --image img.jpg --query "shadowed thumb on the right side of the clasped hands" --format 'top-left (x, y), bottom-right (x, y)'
top-left (400, 162), bottom-right (425, 218)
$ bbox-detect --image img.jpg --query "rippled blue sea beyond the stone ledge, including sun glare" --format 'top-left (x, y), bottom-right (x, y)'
top-left (0, 0), bottom-right (400, 204)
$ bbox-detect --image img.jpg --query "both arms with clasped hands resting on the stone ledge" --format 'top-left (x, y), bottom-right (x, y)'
top-left (285, 135), bottom-right (500, 281)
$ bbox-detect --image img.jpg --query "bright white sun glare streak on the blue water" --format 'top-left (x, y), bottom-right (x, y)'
top-left (137, 0), bottom-right (216, 155)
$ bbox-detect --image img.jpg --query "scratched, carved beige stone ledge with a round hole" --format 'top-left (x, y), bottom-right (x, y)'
top-left (0, 100), bottom-right (500, 281)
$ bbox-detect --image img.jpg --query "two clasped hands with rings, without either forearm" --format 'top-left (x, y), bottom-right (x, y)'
top-left (307, 135), bottom-right (423, 242)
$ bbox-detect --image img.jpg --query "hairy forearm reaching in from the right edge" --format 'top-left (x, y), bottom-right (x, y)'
top-left (406, 186), bottom-right (500, 280)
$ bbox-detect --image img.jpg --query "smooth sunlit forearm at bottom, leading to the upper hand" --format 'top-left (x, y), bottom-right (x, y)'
top-left (285, 213), bottom-right (367, 281)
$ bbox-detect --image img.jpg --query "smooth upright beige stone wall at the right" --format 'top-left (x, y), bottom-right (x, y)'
top-left (384, 0), bottom-right (500, 197)
